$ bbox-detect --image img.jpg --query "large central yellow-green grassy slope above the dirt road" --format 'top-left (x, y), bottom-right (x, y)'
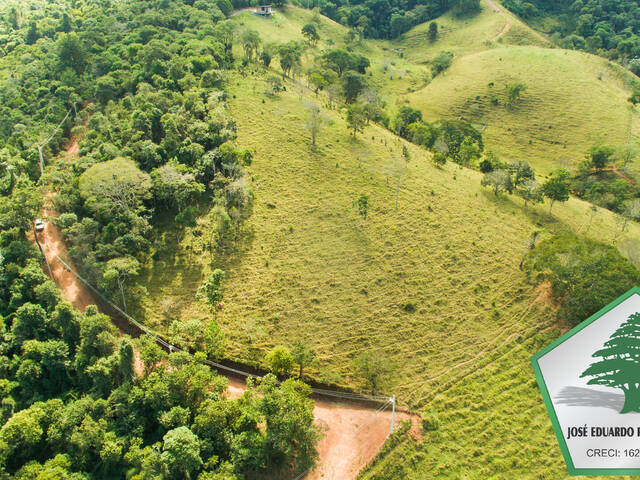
top-left (136, 70), bottom-right (639, 478)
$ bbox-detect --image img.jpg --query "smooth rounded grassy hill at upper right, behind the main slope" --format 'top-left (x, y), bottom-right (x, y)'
top-left (406, 46), bottom-right (639, 172)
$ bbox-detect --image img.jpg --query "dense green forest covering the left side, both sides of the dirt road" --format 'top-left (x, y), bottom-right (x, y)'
top-left (0, 0), bottom-right (318, 480)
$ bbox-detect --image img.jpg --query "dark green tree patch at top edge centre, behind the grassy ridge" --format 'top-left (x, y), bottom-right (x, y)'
top-left (299, 0), bottom-right (481, 38)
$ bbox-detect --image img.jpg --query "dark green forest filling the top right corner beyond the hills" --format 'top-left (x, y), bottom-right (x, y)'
top-left (503, 0), bottom-right (640, 63)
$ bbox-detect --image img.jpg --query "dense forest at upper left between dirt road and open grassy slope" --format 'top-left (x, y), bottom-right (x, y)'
top-left (0, 0), bottom-right (252, 312)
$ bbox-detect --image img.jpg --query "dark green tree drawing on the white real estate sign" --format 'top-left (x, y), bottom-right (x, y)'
top-left (580, 313), bottom-right (640, 413)
